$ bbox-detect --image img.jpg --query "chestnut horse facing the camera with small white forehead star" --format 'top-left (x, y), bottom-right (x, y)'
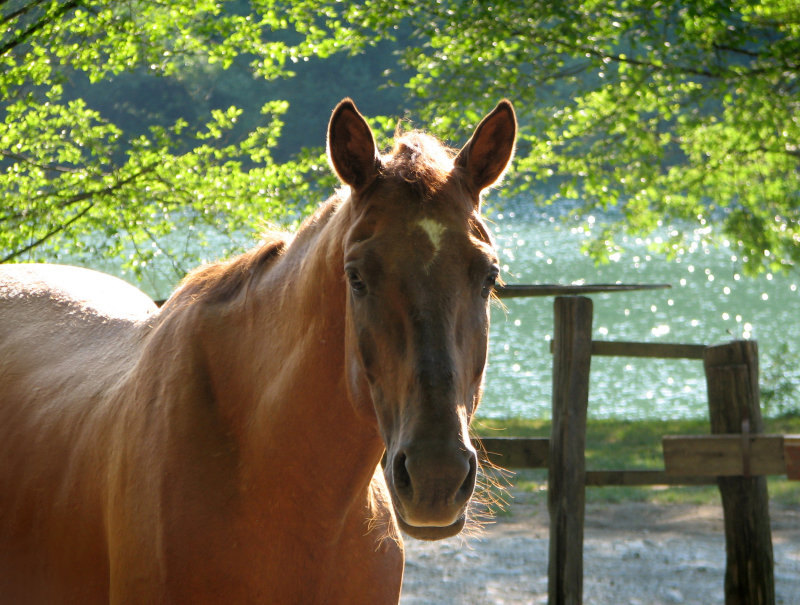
top-left (0, 99), bottom-right (516, 605)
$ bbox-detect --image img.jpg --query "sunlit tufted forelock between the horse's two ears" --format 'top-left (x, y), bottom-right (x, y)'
top-left (383, 130), bottom-right (455, 198)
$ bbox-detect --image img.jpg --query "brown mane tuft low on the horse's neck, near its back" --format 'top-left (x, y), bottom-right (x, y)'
top-left (165, 233), bottom-right (286, 307)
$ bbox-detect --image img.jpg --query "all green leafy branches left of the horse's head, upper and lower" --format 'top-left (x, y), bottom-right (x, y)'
top-left (0, 0), bottom-right (350, 284)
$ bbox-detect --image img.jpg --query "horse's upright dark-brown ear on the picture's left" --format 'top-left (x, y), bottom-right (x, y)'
top-left (328, 99), bottom-right (380, 190)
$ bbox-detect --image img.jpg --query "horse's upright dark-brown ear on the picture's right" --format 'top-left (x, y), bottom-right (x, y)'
top-left (455, 99), bottom-right (517, 201)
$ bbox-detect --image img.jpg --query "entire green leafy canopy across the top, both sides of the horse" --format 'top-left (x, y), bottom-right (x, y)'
top-left (0, 0), bottom-right (800, 284)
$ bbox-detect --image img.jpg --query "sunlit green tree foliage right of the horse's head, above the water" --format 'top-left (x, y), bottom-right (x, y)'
top-left (294, 0), bottom-right (800, 272)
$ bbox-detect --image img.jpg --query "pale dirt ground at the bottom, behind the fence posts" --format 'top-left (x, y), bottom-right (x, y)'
top-left (401, 494), bottom-right (800, 605)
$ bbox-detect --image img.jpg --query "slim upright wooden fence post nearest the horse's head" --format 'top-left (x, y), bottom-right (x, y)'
top-left (547, 296), bottom-right (592, 605)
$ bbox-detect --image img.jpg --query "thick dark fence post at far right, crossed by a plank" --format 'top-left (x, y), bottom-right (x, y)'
top-left (703, 340), bottom-right (775, 605)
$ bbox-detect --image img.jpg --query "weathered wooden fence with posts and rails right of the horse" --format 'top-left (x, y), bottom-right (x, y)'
top-left (481, 294), bottom-right (800, 605)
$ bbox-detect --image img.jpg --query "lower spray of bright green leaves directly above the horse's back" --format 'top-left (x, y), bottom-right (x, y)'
top-left (0, 88), bottom-right (318, 279)
